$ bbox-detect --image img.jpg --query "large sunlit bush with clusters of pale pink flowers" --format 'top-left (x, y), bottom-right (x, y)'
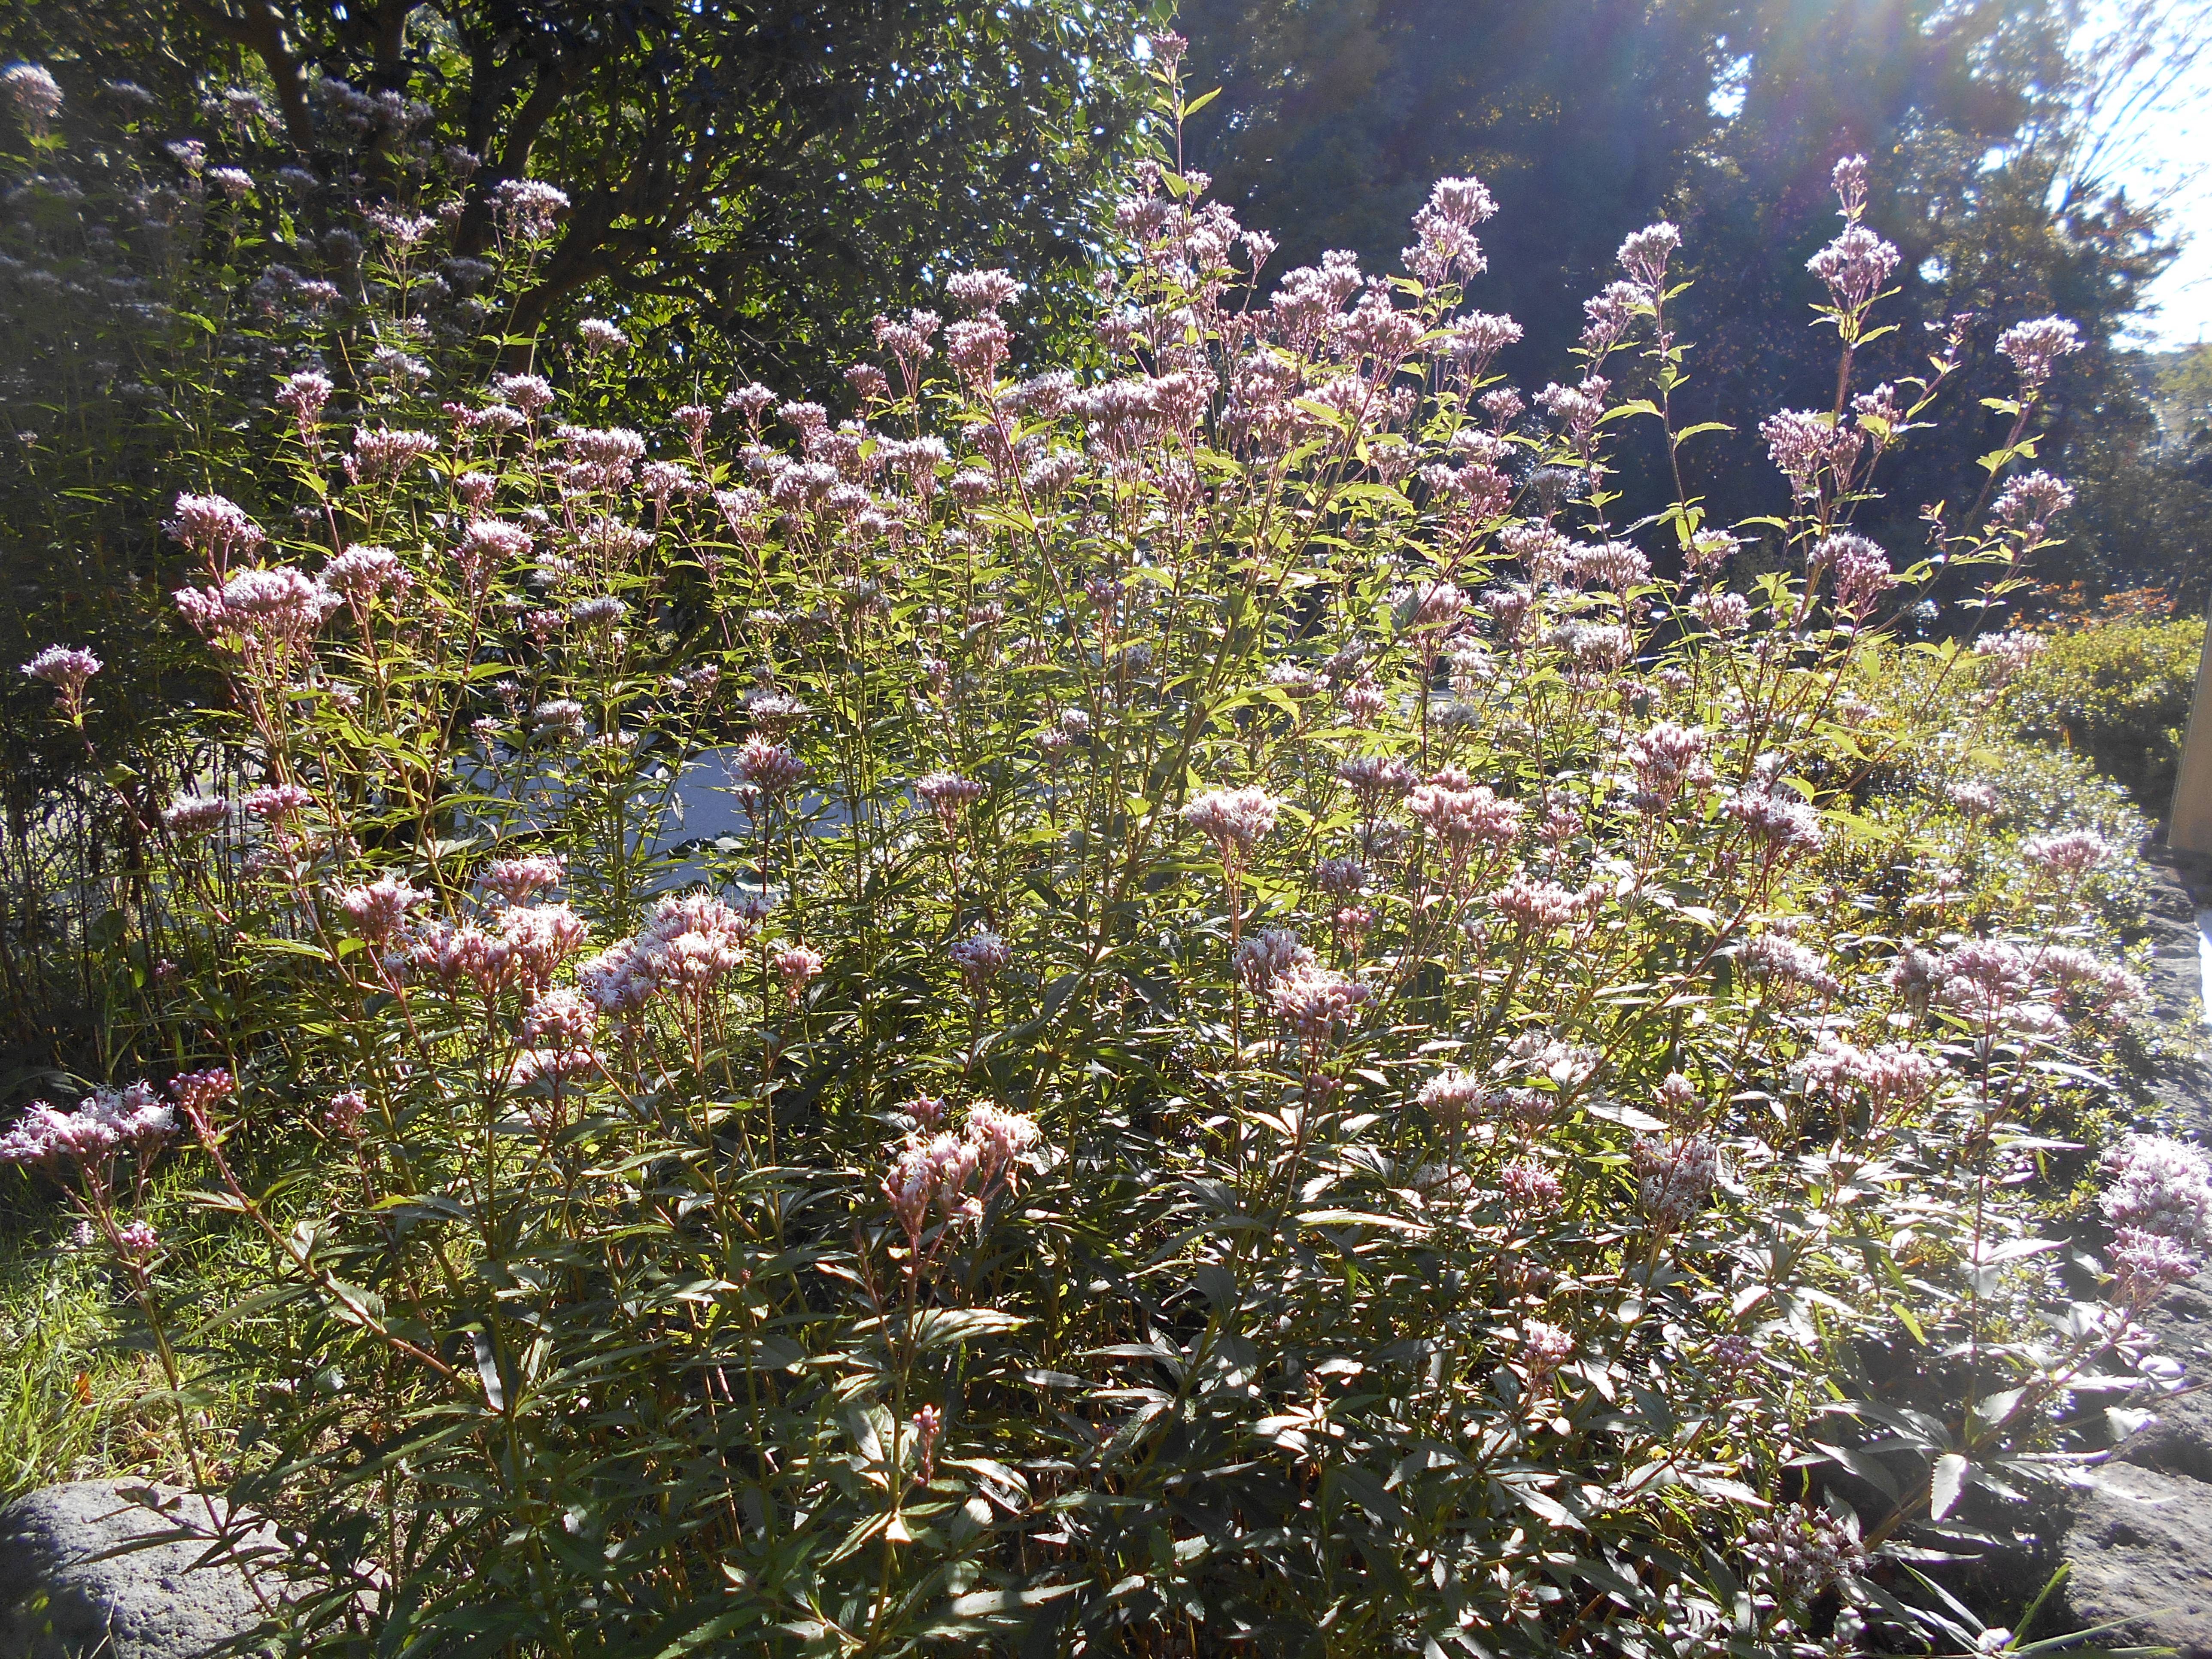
top-left (0, 38), bottom-right (2212, 1655)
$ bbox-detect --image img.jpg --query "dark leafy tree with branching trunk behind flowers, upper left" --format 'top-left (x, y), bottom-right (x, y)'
top-left (0, 0), bottom-right (1155, 374)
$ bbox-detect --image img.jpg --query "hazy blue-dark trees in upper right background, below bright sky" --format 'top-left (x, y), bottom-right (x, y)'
top-left (1181, 0), bottom-right (2212, 597)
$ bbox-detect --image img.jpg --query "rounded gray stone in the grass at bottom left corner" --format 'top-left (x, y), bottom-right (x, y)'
top-left (0, 1480), bottom-right (276, 1659)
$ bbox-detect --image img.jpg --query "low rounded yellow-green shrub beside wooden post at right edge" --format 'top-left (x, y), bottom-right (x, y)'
top-left (2006, 617), bottom-right (2206, 818)
